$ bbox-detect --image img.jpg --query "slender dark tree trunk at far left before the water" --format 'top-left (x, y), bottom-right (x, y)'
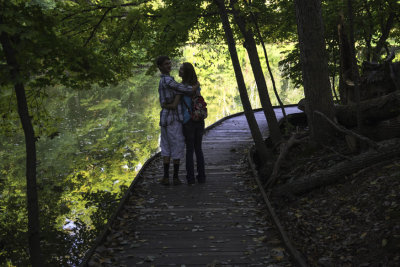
top-left (0, 28), bottom-right (44, 267)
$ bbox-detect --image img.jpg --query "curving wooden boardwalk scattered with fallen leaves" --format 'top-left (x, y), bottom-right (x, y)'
top-left (89, 107), bottom-right (300, 266)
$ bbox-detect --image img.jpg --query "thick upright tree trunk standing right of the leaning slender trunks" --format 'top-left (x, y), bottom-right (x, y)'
top-left (295, 0), bottom-right (334, 143)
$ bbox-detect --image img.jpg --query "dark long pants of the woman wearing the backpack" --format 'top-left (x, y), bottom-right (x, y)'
top-left (183, 120), bottom-right (206, 184)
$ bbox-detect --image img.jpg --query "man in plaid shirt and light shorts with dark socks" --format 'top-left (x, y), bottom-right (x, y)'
top-left (156, 56), bottom-right (199, 185)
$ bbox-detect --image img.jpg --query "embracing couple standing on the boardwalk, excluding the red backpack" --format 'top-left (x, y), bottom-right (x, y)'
top-left (156, 56), bottom-right (206, 185)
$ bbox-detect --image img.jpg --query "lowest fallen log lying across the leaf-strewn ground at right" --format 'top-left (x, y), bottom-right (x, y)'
top-left (272, 139), bottom-right (400, 196)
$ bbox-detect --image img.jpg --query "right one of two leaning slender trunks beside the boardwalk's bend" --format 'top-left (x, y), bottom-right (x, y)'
top-left (231, 0), bottom-right (282, 144)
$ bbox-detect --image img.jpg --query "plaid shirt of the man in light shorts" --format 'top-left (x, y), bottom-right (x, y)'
top-left (158, 74), bottom-right (192, 126)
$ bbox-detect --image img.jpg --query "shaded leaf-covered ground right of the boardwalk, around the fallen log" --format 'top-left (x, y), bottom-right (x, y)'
top-left (260, 136), bottom-right (400, 266)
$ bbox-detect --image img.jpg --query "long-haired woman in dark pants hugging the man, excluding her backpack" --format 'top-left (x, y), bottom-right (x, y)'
top-left (179, 62), bottom-right (206, 185)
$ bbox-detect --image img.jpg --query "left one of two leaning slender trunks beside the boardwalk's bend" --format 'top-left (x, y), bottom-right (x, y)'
top-left (214, 0), bottom-right (271, 162)
